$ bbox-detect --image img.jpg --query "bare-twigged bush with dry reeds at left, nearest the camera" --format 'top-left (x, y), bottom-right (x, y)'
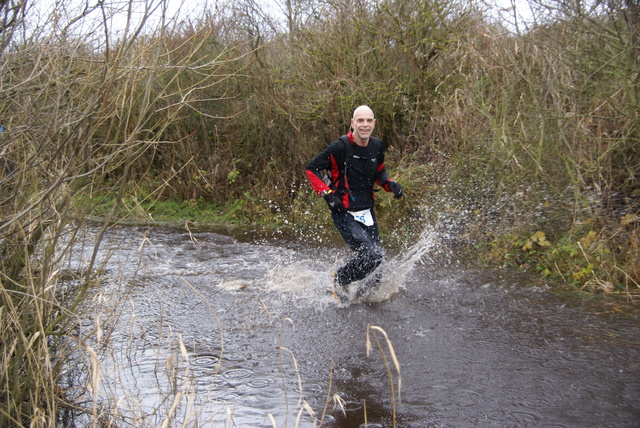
top-left (0, 2), bottom-right (248, 426)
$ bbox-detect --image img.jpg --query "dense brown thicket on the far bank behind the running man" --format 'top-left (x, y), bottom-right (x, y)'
top-left (135, 0), bottom-right (640, 290)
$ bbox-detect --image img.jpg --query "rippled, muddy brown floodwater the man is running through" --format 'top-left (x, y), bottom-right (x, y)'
top-left (66, 228), bottom-right (640, 428)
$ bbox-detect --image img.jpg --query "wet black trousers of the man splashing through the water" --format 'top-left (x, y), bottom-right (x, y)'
top-left (331, 208), bottom-right (383, 286)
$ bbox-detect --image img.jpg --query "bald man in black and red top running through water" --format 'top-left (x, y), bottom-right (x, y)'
top-left (306, 106), bottom-right (402, 303)
